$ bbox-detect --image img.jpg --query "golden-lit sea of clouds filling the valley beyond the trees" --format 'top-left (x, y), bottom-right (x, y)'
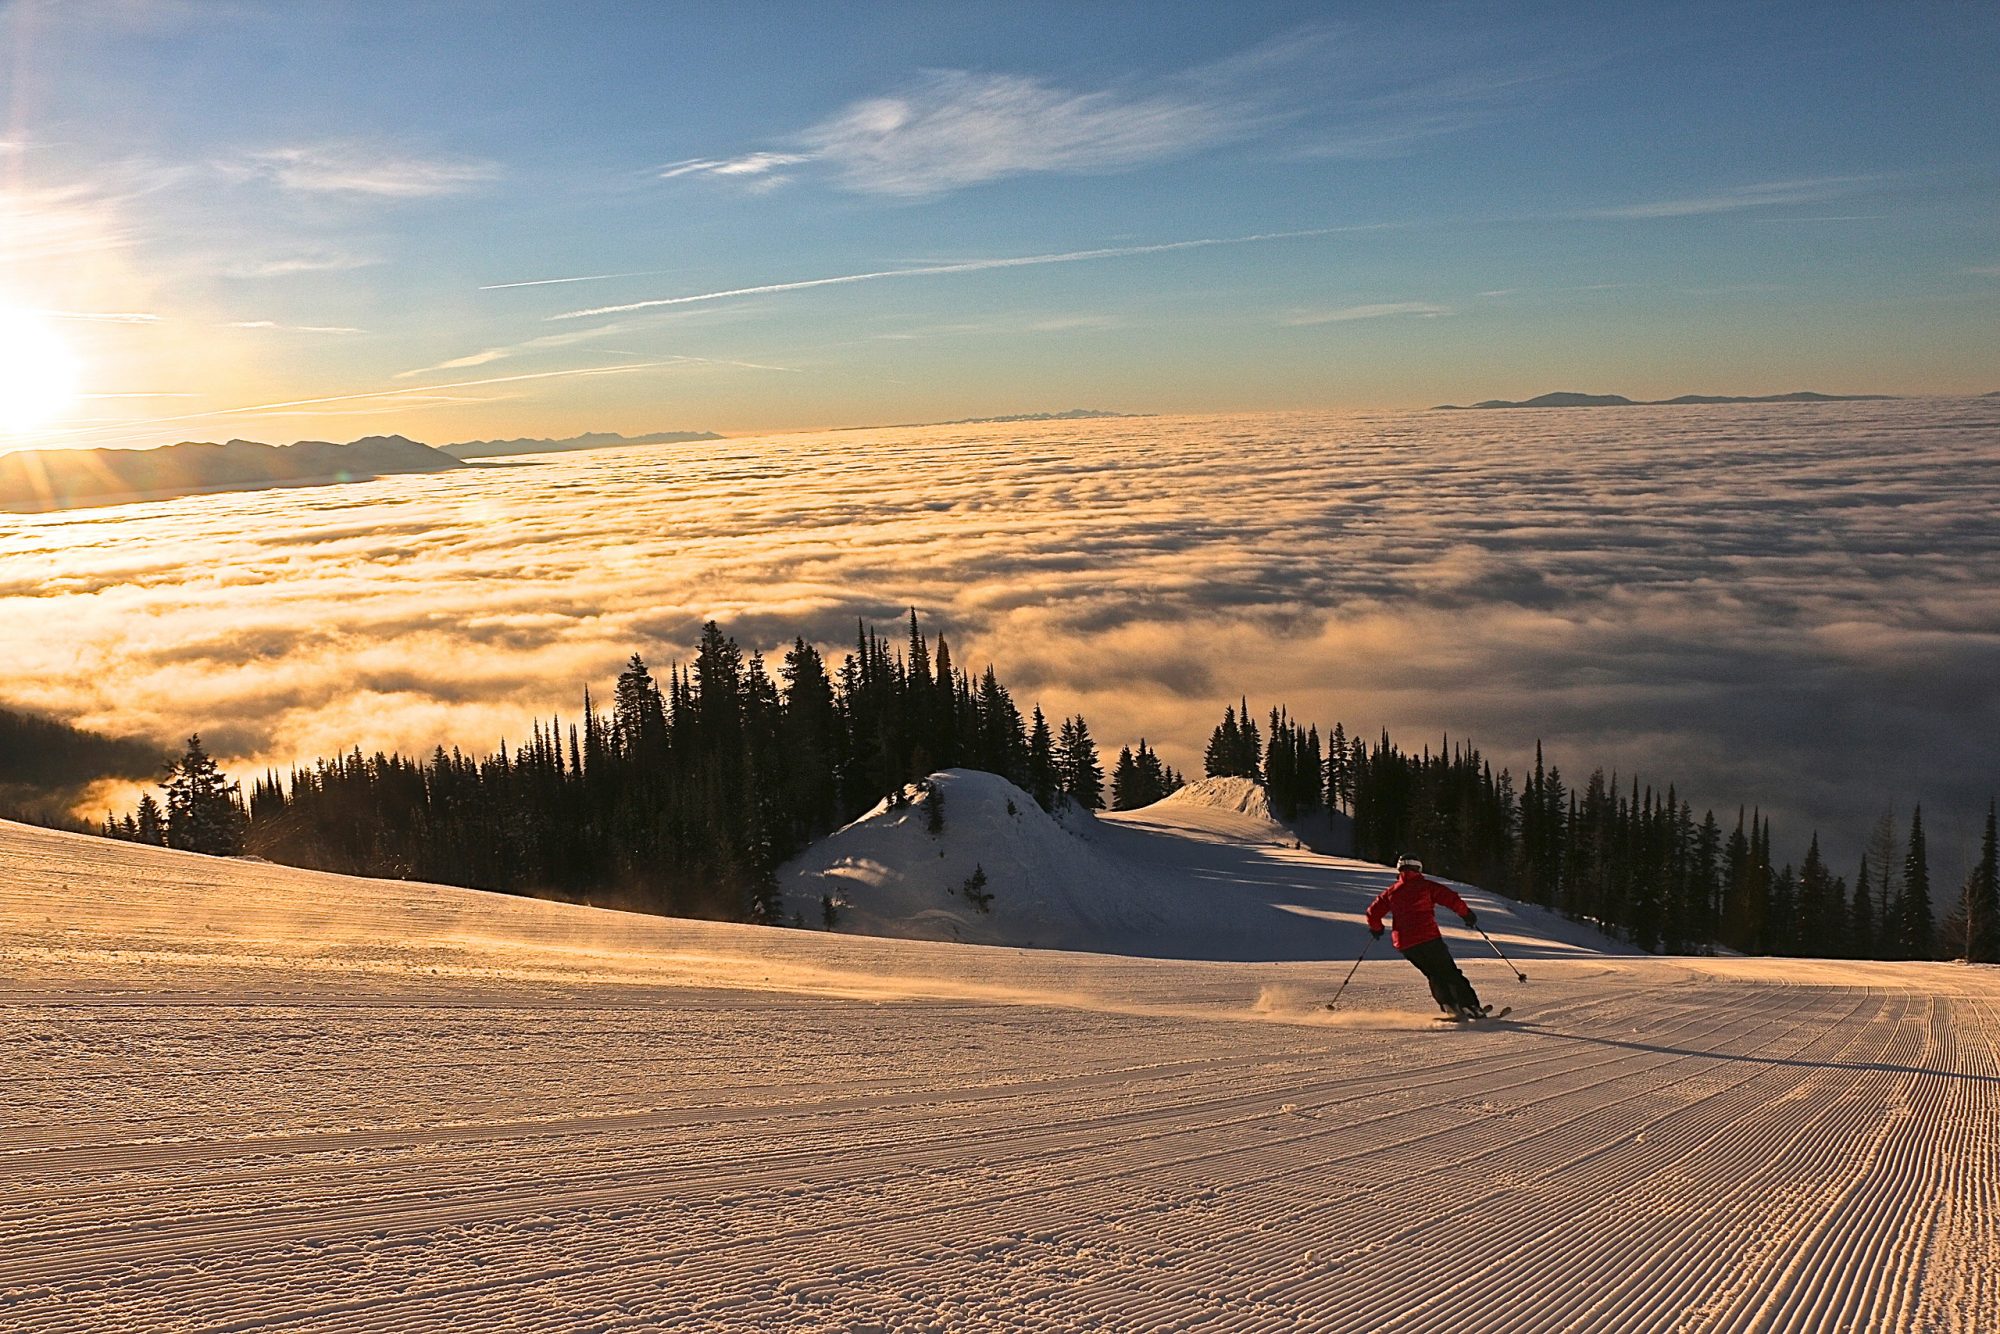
top-left (0, 400), bottom-right (2000, 874)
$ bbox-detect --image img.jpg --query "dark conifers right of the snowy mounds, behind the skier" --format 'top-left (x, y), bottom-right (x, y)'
top-left (1206, 708), bottom-right (2000, 962)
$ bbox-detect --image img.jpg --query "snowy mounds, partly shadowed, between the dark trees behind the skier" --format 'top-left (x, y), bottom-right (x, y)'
top-left (780, 770), bottom-right (1630, 960)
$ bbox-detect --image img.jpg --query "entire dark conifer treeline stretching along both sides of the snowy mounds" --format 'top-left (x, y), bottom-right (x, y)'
top-left (106, 612), bottom-right (2000, 960)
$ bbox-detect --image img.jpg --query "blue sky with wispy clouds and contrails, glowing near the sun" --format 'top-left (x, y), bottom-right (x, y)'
top-left (0, 0), bottom-right (2000, 448)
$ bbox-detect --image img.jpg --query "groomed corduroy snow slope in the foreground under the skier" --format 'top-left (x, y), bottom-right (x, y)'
top-left (0, 824), bottom-right (2000, 1334)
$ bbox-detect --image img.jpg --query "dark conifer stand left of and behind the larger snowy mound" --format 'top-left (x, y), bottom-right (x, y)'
top-left (106, 612), bottom-right (1164, 922)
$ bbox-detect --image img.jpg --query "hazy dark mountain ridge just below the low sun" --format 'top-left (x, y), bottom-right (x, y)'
top-left (0, 436), bottom-right (466, 514)
